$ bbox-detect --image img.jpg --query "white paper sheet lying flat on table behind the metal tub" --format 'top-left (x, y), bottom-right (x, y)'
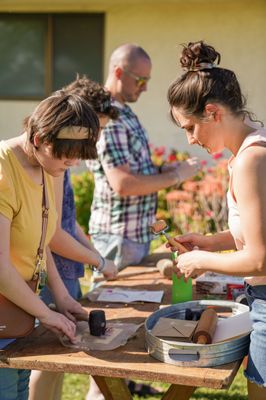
top-left (97, 288), bottom-right (164, 303)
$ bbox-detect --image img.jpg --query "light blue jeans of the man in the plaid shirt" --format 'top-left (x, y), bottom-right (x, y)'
top-left (92, 233), bottom-right (150, 270)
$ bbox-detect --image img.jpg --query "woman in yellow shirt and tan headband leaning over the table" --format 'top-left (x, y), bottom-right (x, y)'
top-left (0, 91), bottom-right (99, 400)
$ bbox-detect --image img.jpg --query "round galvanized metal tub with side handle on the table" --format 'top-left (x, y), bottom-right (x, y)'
top-left (145, 300), bottom-right (250, 367)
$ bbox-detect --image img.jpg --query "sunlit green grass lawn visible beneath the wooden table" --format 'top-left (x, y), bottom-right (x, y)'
top-left (62, 368), bottom-right (247, 400)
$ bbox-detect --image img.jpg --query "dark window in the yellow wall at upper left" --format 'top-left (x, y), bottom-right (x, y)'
top-left (0, 14), bottom-right (104, 99)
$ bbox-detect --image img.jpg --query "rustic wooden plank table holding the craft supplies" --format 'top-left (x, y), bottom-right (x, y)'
top-left (0, 254), bottom-right (241, 400)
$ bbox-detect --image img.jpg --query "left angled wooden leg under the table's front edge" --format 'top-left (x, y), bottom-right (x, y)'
top-left (93, 376), bottom-right (132, 400)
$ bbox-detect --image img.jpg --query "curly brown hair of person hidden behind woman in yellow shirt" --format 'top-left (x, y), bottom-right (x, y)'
top-left (63, 74), bottom-right (119, 119)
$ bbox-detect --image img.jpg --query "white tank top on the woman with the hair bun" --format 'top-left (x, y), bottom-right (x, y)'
top-left (227, 119), bottom-right (266, 286)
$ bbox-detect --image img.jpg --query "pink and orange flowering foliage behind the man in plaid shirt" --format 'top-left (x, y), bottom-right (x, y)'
top-left (71, 146), bottom-right (228, 238)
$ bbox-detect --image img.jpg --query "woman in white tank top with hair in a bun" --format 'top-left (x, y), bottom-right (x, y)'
top-left (168, 41), bottom-right (266, 400)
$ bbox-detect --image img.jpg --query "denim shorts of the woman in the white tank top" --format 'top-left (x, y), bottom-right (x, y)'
top-left (244, 283), bottom-right (266, 387)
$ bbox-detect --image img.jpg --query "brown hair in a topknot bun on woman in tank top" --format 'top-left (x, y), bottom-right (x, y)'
top-left (167, 40), bottom-right (254, 120)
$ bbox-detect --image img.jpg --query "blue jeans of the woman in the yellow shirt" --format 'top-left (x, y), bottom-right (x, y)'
top-left (0, 368), bottom-right (31, 400)
